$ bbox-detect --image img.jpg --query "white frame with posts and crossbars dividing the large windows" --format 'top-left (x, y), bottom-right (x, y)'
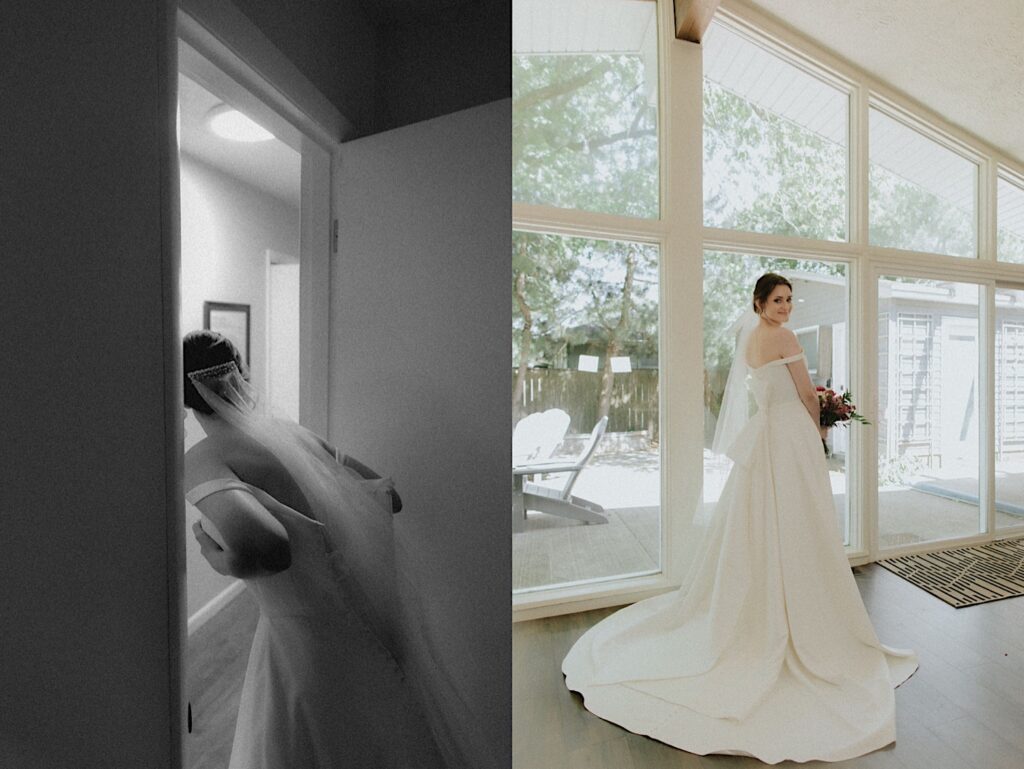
top-left (512, 0), bottom-right (1024, 621)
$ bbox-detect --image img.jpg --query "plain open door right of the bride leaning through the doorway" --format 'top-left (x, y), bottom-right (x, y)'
top-left (330, 100), bottom-right (512, 769)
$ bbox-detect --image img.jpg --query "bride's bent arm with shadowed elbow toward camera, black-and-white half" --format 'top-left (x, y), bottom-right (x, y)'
top-left (193, 488), bottom-right (292, 579)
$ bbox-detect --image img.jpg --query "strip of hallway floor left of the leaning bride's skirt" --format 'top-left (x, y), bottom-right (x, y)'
top-left (184, 591), bottom-right (259, 769)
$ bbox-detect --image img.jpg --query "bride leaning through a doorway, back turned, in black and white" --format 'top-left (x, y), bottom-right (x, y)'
top-left (183, 331), bottom-right (443, 769)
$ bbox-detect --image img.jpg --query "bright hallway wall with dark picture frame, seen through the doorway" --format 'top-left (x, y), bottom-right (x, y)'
top-left (180, 155), bottom-right (299, 629)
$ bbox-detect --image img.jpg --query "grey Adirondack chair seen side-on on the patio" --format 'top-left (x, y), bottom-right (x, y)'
top-left (512, 417), bottom-right (608, 531)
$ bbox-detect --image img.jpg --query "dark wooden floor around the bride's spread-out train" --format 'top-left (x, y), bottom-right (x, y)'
top-left (512, 565), bottom-right (1024, 769)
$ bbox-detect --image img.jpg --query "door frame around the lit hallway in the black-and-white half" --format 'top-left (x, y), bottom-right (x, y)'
top-left (172, 0), bottom-right (339, 766)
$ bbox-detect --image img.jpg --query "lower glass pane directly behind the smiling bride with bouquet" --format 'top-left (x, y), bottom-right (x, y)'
top-left (695, 251), bottom-right (857, 545)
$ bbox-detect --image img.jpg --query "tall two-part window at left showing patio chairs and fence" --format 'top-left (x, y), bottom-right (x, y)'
top-left (511, 0), bottom-right (665, 605)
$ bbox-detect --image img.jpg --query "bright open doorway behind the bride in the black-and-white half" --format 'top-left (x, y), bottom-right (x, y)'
top-left (177, 31), bottom-right (331, 769)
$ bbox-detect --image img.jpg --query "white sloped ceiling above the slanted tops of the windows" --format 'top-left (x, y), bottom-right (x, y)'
top-left (737, 0), bottom-right (1024, 164)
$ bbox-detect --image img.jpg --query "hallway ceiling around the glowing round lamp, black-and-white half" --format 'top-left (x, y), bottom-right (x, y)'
top-left (178, 74), bottom-right (301, 208)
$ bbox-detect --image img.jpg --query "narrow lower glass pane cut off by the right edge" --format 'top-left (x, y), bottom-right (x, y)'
top-left (995, 289), bottom-right (1024, 528)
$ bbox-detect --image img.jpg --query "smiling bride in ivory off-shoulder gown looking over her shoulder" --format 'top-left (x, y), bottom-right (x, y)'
top-left (562, 273), bottom-right (918, 764)
